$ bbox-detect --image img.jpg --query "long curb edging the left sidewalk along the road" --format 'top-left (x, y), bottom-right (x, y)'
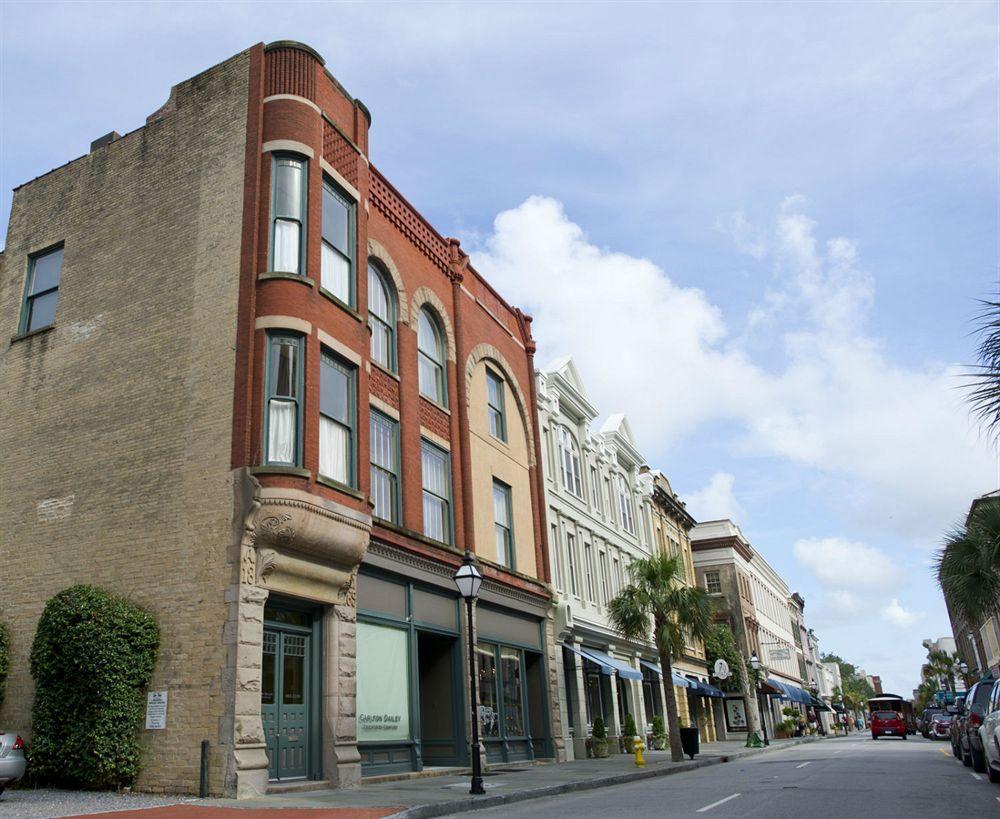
top-left (386, 737), bottom-right (824, 819)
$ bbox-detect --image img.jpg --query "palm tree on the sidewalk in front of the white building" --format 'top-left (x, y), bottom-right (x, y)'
top-left (608, 552), bottom-right (713, 762)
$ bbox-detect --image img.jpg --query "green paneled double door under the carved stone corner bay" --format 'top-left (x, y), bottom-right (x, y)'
top-left (260, 628), bottom-right (311, 779)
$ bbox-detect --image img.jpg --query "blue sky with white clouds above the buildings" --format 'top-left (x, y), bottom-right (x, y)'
top-left (0, 0), bottom-right (1000, 692)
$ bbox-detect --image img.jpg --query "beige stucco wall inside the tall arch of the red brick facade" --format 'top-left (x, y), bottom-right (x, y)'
top-left (469, 361), bottom-right (538, 577)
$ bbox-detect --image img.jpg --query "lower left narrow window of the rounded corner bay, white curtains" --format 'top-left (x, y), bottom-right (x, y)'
top-left (264, 334), bottom-right (302, 466)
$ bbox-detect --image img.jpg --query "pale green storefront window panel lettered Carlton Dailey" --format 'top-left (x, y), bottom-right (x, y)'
top-left (357, 623), bottom-right (410, 742)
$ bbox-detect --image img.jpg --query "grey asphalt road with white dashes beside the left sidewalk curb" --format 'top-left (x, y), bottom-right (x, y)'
top-left (444, 736), bottom-right (1000, 819)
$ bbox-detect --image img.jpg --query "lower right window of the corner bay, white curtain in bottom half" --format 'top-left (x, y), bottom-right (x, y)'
top-left (319, 351), bottom-right (356, 486)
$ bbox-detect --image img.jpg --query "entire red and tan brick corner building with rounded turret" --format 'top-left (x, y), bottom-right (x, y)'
top-left (0, 42), bottom-right (561, 796)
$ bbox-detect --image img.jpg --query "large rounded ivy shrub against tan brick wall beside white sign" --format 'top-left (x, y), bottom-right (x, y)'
top-left (28, 586), bottom-right (160, 789)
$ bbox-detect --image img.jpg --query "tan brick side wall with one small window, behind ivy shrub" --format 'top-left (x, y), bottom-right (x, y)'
top-left (0, 53), bottom-right (249, 791)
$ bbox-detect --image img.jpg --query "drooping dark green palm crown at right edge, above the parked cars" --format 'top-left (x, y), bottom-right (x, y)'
top-left (937, 498), bottom-right (1000, 624)
